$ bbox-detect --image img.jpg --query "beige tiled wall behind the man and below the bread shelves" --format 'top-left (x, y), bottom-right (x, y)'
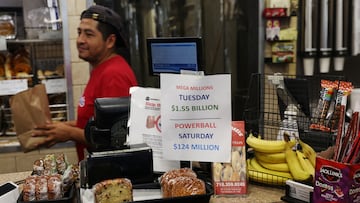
top-left (0, 0), bottom-right (89, 173)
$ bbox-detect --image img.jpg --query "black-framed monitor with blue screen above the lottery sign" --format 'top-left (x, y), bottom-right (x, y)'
top-left (146, 37), bottom-right (202, 75)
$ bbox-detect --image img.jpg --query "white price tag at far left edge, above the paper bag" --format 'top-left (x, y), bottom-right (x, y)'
top-left (0, 79), bottom-right (28, 96)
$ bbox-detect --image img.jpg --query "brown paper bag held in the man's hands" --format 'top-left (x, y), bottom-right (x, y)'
top-left (10, 84), bottom-right (51, 152)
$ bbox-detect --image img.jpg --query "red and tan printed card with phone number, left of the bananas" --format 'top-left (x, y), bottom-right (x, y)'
top-left (212, 121), bottom-right (247, 195)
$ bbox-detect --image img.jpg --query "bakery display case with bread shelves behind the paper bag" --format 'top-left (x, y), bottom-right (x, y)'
top-left (0, 0), bottom-right (73, 144)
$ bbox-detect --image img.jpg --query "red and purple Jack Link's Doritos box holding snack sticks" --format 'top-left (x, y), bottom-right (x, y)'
top-left (313, 157), bottom-right (360, 203)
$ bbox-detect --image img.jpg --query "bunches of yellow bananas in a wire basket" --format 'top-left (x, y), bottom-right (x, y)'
top-left (246, 134), bottom-right (316, 185)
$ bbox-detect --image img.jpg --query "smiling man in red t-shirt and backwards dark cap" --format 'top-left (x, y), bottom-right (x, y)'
top-left (33, 5), bottom-right (137, 161)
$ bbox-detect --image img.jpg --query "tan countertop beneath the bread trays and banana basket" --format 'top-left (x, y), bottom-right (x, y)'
top-left (0, 171), bottom-right (285, 203)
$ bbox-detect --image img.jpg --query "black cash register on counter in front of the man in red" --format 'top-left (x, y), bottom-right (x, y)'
top-left (80, 97), bottom-right (154, 188)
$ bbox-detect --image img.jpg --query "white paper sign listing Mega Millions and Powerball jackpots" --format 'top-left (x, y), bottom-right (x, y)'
top-left (160, 74), bottom-right (231, 162)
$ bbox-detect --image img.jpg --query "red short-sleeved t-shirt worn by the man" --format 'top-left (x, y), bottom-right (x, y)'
top-left (76, 55), bottom-right (137, 161)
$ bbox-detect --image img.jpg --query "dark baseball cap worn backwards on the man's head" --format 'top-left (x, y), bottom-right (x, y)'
top-left (80, 5), bottom-right (128, 47)
